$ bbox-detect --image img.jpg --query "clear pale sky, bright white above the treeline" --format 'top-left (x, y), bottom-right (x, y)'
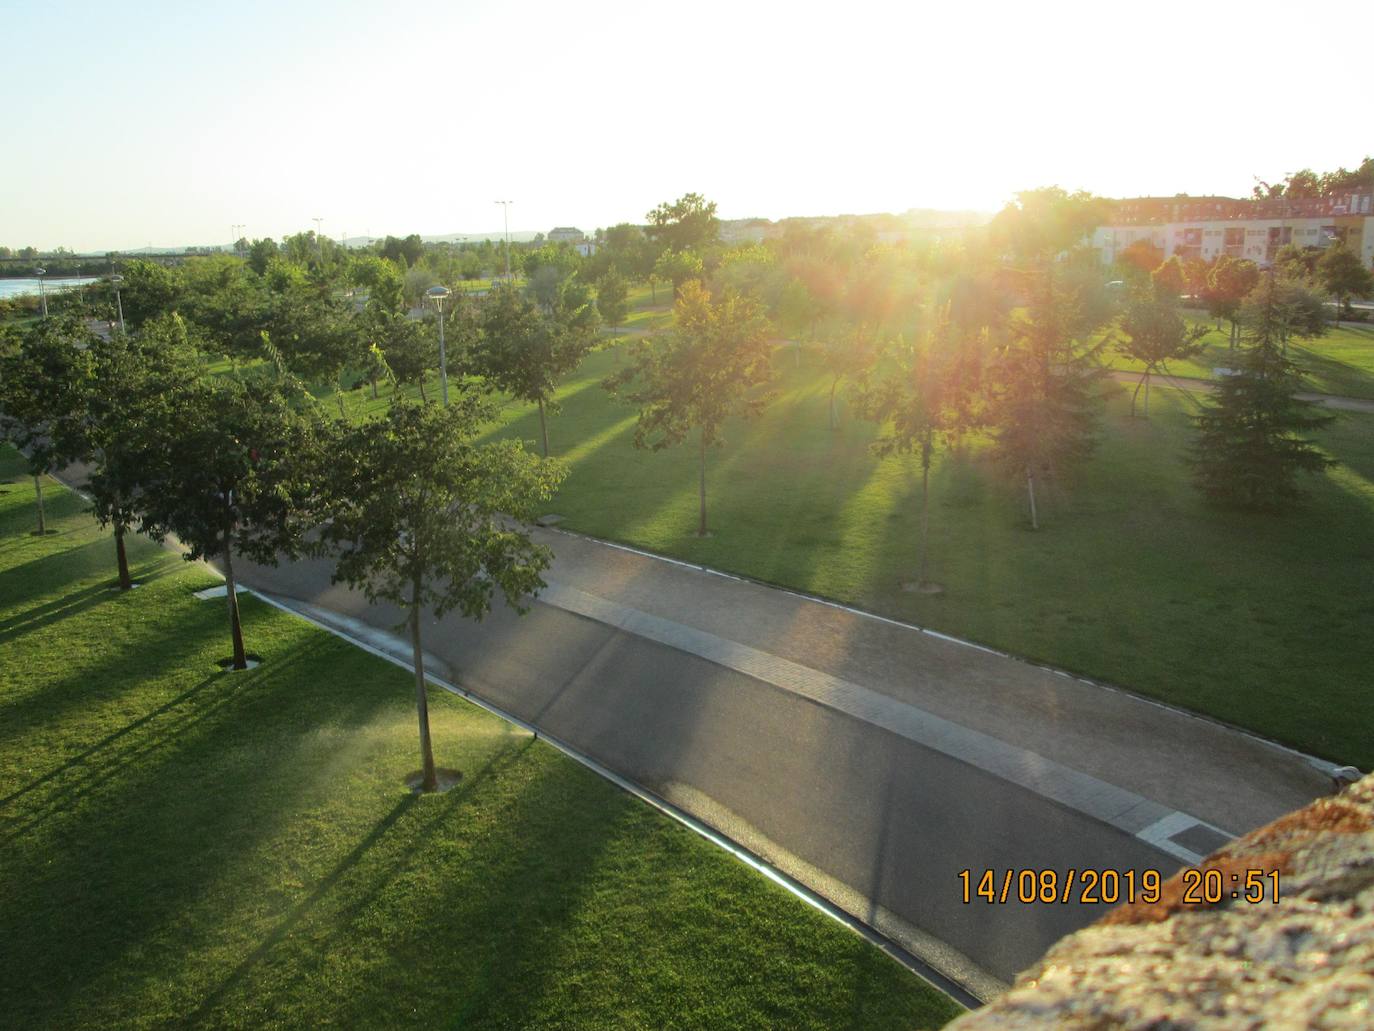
top-left (0, 0), bottom-right (1374, 250)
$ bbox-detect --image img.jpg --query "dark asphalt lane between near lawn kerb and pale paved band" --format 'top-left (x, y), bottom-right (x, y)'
top-left (236, 561), bottom-right (1203, 997)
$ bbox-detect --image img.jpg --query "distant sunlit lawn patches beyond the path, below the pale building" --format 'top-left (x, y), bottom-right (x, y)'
top-left (1107, 316), bottom-right (1374, 399)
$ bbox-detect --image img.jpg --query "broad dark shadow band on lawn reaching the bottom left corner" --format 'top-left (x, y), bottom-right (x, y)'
top-left (0, 635), bottom-right (394, 1026)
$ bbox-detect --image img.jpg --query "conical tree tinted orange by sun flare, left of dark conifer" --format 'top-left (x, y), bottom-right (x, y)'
top-left (988, 267), bottom-right (1103, 529)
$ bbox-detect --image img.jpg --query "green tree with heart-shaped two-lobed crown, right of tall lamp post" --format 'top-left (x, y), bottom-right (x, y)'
top-left (471, 278), bottom-right (596, 458)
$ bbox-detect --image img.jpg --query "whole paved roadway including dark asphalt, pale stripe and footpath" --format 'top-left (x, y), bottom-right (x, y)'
top-left (225, 531), bottom-right (1327, 997)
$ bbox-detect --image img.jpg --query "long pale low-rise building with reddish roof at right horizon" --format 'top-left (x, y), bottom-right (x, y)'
top-left (1092, 192), bottom-right (1374, 268)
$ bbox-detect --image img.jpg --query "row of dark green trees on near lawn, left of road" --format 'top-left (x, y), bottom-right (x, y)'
top-left (0, 313), bottom-right (562, 790)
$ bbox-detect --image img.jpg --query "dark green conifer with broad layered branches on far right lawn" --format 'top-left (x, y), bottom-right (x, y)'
top-left (1190, 272), bottom-right (1333, 510)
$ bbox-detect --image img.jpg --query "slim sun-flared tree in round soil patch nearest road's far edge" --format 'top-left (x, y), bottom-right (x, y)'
top-left (855, 327), bottom-right (959, 592)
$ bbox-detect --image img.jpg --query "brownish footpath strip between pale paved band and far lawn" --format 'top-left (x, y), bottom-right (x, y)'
top-left (527, 531), bottom-right (1330, 851)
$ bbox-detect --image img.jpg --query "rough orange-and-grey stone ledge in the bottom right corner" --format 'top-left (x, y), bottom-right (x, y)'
top-left (948, 775), bottom-right (1374, 1031)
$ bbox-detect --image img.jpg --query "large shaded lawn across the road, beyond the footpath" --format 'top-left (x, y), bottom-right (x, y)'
top-left (480, 348), bottom-right (1374, 768)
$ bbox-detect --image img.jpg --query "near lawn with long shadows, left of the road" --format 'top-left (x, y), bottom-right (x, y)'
top-left (0, 451), bottom-right (955, 1028)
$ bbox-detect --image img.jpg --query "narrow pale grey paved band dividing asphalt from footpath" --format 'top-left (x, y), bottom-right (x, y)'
top-left (539, 580), bottom-right (1234, 863)
